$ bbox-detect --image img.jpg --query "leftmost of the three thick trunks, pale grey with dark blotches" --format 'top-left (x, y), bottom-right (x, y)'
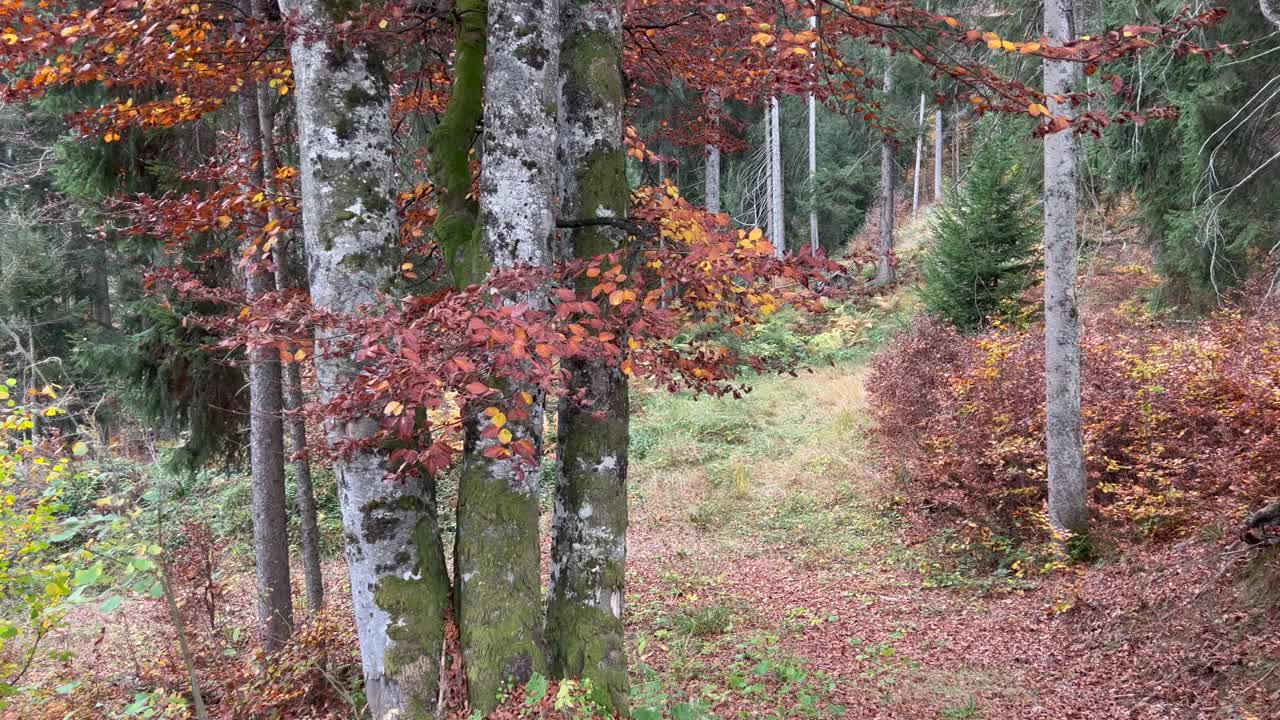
top-left (283, 0), bottom-right (449, 720)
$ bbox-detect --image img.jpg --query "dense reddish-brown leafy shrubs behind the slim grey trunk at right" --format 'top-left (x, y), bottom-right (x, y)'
top-left (868, 295), bottom-right (1280, 538)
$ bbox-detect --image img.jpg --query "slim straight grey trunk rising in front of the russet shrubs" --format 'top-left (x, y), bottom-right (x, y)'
top-left (1044, 0), bottom-right (1089, 533)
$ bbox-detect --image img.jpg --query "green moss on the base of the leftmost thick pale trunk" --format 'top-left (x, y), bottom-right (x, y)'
top-left (374, 515), bottom-right (449, 719)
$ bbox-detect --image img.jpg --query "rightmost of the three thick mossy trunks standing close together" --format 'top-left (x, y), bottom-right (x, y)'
top-left (547, 0), bottom-right (629, 714)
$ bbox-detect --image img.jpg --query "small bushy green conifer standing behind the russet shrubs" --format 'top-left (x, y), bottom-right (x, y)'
top-left (922, 127), bottom-right (1038, 332)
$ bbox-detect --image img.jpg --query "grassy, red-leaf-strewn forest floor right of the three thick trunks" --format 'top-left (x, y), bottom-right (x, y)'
top-left (628, 353), bottom-right (1280, 720)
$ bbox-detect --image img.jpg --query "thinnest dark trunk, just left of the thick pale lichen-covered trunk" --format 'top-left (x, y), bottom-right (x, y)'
top-left (253, 73), bottom-right (324, 611)
